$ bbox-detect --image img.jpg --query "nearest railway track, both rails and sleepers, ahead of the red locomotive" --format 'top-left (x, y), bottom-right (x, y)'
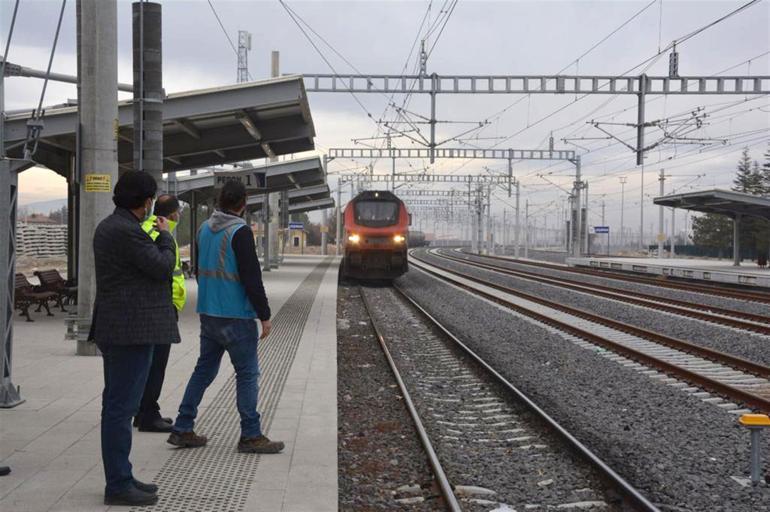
top-left (360, 287), bottom-right (659, 512)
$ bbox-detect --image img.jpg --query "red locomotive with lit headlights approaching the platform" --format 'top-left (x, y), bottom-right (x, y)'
top-left (342, 190), bottom-right (410, 279)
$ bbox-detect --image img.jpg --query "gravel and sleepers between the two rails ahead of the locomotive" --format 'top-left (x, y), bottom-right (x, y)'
top-left (364, 288), bottom-right (620, 511)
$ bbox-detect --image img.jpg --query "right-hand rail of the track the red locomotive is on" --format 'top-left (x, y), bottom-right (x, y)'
top-left (393, 284), bottom-right (660, 512)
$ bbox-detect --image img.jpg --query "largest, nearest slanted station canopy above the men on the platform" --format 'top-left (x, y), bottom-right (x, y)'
top-left (5, 75), bottom-right (315, 177)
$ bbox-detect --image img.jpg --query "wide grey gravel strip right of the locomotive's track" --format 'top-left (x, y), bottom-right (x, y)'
top-left (397, 269), bottom-right (770, 512)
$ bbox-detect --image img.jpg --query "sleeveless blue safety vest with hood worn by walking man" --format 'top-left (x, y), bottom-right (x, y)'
top-left (197, 219), bottom-right (257, 318)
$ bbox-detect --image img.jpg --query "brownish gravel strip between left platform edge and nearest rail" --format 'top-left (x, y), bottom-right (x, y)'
top-left (337, 285), bottom-right (444, 512)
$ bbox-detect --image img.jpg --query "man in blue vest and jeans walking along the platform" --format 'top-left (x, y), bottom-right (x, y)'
top-left (168, 181), bottom-right (284, 453)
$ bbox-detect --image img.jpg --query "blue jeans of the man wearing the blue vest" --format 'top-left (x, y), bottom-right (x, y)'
top-left (174, 315), bottom-right (262, 437)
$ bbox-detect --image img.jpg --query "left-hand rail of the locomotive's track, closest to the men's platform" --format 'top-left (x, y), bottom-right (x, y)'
top-left (358, 286), bottom-right (462, 512)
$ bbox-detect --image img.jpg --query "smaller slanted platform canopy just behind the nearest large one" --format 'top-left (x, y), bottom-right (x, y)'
top-left (166, 156), bottom-right (329, 203)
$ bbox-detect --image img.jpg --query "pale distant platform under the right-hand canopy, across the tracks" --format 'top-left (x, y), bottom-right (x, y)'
top-left (567, 257), bottom-right (770, 288)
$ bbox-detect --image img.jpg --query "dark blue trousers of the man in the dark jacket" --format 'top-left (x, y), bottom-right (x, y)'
top-left (99, 345), bottom-right (153, 495)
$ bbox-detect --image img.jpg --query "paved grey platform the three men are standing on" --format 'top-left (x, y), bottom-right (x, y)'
top-left (0, 256), bottom-right (339, 512)
